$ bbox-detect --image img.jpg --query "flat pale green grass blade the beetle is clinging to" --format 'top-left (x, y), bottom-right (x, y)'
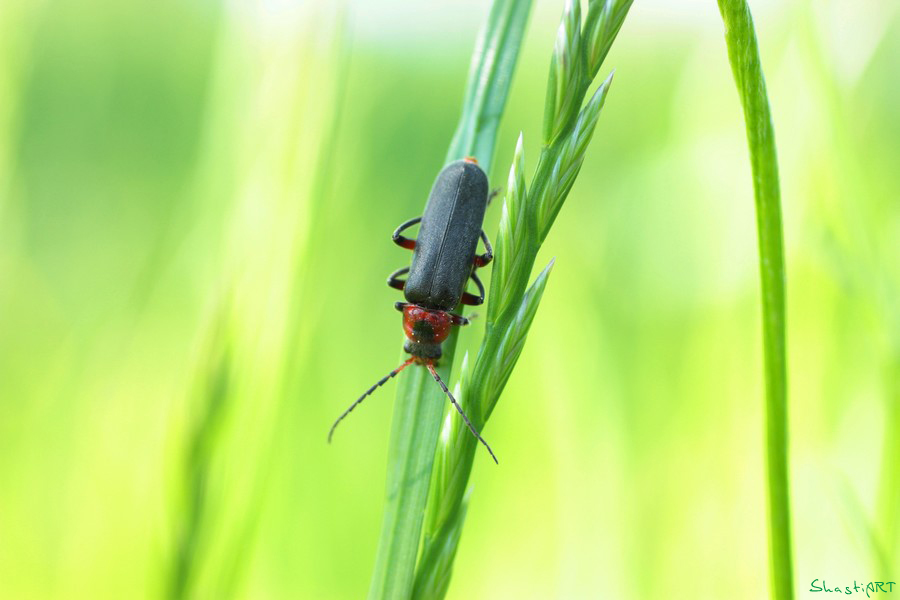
top-left (369, 0), bottom-right (531, 600)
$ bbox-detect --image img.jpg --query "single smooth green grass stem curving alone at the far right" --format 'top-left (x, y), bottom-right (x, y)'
top-left (718, 0), bottom-right (794, 600)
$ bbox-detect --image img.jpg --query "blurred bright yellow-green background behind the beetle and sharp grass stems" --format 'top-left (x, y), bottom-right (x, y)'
top-left (0, 0), bottom-right (900, 599)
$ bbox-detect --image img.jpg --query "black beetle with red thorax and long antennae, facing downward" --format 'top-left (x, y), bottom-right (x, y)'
top-left (328, 157), bottom-right (497, 463)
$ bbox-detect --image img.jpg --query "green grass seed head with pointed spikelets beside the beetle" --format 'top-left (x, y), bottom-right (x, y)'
top-left (414, 0), bottom-right (631, 600)
